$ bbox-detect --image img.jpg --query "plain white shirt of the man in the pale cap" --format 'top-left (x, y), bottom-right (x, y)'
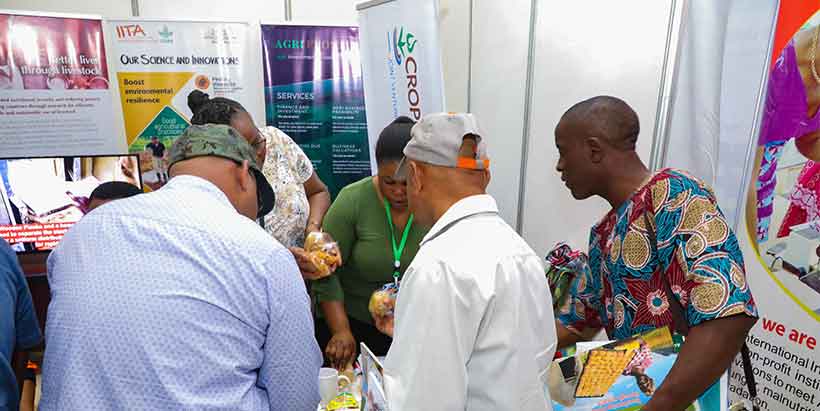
top-left (384, 195), bottom-right (557, 411)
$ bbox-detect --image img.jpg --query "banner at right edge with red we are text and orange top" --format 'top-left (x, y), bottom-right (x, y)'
top-left (740, 0), bottom-right (820, 411)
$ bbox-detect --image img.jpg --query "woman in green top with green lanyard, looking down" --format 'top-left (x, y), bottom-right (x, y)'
top-left (313, 117), bottom-right (427, 368)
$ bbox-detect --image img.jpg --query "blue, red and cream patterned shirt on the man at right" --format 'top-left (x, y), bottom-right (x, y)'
top-left (559, 170), bottom-right (757, 340)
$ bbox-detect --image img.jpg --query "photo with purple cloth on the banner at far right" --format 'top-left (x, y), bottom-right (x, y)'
top-left (748, 8), bottom-right (820, 308)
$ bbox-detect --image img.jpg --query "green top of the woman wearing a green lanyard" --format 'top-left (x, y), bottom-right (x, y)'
top-left (312, 177), bottom-right (428, 324)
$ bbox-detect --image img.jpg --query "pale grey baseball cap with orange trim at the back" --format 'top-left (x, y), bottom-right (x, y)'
top-left (395, 113), bottom-right (490, 180)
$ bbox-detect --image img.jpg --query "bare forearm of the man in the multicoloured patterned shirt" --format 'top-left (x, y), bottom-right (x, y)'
top-left (642, 315), bottom-right (757, 411)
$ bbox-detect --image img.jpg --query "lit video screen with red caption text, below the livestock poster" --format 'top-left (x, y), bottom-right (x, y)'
top-left (0, 155), bottom-right (142, 253)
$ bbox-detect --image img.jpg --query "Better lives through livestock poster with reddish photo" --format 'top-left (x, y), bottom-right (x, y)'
top-left (0, 13), bottom-right (122, 156)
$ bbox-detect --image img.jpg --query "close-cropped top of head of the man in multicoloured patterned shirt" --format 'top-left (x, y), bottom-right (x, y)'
top-left (558, 96), bottom-right (641, 151)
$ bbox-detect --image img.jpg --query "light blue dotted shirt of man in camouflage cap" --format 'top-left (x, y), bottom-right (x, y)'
top-left (40, 176), bottom-right (322, 411)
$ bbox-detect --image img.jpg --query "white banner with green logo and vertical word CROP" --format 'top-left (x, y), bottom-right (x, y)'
top-left (358, 0), bottom-right (444, 170)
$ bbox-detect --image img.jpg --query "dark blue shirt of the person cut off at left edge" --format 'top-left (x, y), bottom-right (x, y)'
top-left (0, 238), bottom-right (41, 410)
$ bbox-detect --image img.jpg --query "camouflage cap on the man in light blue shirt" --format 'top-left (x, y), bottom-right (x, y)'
top-left (168, 124), bottom-right (276, 218)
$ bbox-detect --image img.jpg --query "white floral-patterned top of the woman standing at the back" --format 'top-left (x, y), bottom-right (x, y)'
top-left (262, 127), bottom-right (313, 247)
